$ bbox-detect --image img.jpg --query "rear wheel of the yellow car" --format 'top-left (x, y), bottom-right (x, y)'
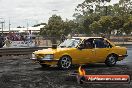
top-left (105, 54), bottom-right (118, 67)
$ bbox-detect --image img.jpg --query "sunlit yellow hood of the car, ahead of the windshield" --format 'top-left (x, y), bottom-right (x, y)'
top-left (33, 48), bottom-right (71, 54)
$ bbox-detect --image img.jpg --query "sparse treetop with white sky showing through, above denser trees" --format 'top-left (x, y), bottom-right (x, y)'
top-left (75, 0), bottom-right (111, 15)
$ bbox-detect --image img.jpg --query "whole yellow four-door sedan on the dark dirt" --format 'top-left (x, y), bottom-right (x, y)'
top-left (31, 37), bottom-right (127, 69)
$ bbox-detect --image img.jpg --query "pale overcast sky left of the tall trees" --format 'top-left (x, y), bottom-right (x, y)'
top-left (0, 0), bottom-right (118, 27)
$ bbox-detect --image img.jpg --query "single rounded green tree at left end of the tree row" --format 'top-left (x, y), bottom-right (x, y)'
top-left (40, 15), bottom-right (63, 37)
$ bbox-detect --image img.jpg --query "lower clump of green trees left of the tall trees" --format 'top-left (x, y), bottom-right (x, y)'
top-left (40, 15), bottom-right (78, 37)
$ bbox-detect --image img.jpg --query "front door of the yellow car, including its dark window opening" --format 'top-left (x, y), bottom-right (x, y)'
top-left (72, 39), bottom-right (95, 64)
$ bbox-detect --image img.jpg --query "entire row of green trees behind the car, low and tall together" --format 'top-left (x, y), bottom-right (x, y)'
top-left (40, 0), bottom-right (132, 37)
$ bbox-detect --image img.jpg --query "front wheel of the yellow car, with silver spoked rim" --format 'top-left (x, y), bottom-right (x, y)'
top-left (58, 56), bottom-right (72, 70)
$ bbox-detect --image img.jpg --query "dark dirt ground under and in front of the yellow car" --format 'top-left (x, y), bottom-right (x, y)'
top-left (0, 56), bottom-right (132, 88)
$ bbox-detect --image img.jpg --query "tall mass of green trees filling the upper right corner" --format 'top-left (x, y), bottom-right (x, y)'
top-left (73, 0), bottom-right (132, 34)
